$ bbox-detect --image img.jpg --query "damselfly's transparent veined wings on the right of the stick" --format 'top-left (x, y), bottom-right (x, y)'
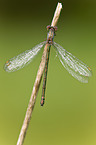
top-left (53, 42), bottom-right (92, 83)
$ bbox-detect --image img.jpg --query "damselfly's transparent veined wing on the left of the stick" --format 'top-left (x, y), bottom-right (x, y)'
top-left (4, 42), bottom-right (45, 72)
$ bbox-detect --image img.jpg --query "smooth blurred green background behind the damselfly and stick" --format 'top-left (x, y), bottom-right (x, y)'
top-left (0, 0), bottom-right (96, 145)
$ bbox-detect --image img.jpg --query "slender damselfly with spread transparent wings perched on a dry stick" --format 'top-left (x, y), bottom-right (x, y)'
top-left (4, 26), bottom-right (92, 106)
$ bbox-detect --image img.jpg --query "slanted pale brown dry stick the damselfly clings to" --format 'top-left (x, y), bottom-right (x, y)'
top-left (17, 3), bottom-right (62, 145)
